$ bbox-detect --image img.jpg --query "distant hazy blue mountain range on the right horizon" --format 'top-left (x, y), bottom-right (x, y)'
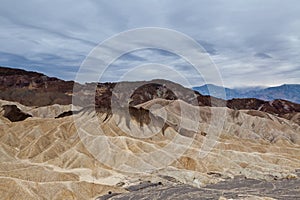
top-left (193, 84), bottom-right (300, 103)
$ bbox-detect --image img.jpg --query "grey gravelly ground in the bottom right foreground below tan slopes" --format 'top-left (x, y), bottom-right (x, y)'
top-left (97, 172), bottom-right (300, 200)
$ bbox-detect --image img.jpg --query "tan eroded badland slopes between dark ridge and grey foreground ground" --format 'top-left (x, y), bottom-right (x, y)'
top-left (0, 100), bottom-right (300, 199)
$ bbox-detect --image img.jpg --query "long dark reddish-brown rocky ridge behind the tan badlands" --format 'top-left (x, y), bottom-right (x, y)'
top-left (0, 67), bottom-right (300, 123)
